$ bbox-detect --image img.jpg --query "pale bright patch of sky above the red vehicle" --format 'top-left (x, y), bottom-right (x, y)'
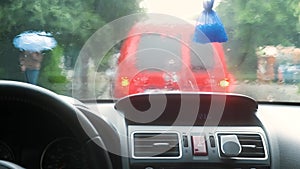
top-left (141, 0), bottom-right (220, 20)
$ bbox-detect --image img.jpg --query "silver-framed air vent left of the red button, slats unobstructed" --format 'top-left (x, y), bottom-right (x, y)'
top-left (132, 133), bottom-right (181, 158)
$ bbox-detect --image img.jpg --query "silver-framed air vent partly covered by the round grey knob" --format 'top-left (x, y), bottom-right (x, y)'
top-left (218, 133), bottom-right (266, 159)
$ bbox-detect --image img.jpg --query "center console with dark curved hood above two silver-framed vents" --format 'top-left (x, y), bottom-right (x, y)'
top-left (115, 93), bottom-right (270, 169)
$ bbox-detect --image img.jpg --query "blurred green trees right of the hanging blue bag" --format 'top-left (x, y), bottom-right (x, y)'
top-left (216, 0), bottom-right (300, 79)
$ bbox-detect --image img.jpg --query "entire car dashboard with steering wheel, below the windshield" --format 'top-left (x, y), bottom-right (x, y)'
top-left (0, 83), bottom-right (300, 169)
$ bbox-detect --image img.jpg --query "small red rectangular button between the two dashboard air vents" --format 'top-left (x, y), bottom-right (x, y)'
top-left (192, 136), bottom-right (207, 156)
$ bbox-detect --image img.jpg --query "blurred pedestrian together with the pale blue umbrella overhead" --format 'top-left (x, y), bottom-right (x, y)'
top-left (13, 31), bottom-right (56, 85)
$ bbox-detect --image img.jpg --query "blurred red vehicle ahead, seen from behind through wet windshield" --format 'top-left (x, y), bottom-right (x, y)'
top-left (113, 23), bottom-right (234, 98)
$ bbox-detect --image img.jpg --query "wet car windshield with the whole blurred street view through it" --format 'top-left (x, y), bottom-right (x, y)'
top-left (0, 0), bottom-right (300, 103)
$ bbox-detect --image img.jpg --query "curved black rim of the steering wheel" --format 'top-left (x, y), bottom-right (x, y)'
top-left (0, 80), bottom-right (113, 169)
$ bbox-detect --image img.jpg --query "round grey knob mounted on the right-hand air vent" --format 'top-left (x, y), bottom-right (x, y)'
top-left (221, 135), bottom-right (242, 157)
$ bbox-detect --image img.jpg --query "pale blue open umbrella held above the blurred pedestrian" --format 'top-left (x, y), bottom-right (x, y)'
top-left (13, 31), bottom-right (57, 52)
